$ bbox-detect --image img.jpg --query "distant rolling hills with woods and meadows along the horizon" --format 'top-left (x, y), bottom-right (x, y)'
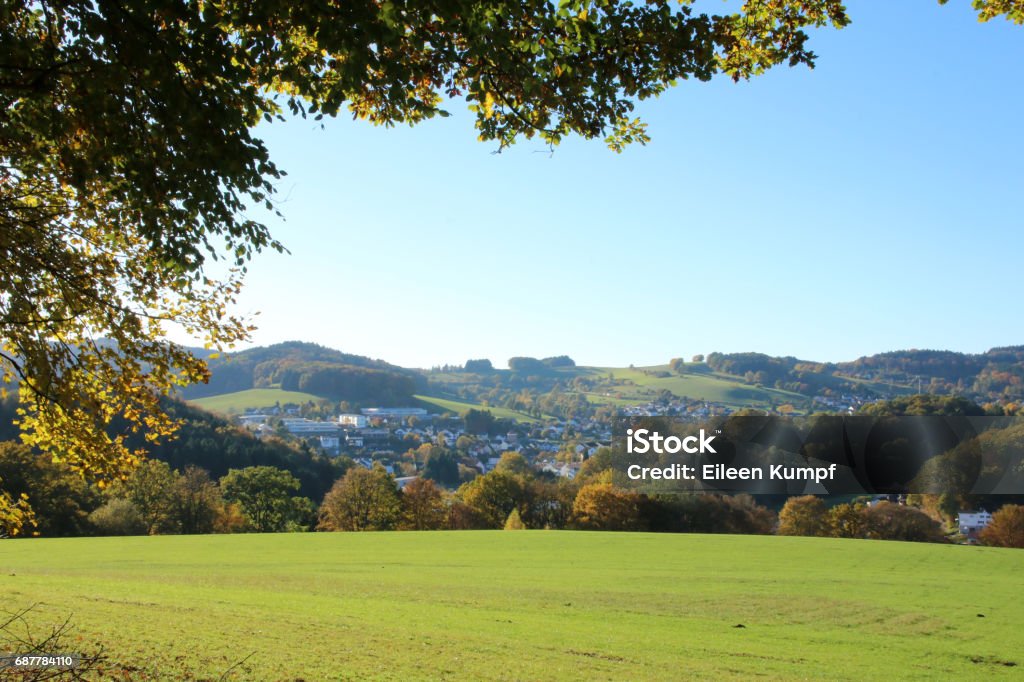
top-left (183, 342), bottom-right (1024, 422)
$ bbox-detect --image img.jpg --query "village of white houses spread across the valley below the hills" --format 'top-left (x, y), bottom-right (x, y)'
top-left (220, 364), bottom-right (1011, 544)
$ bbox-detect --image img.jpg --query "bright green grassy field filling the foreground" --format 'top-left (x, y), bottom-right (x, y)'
top-left (0, 530), bottom-right (1024, 680)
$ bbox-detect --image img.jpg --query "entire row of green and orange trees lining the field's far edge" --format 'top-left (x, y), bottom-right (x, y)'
top-left (6, 442), bottom-right (1024, 547)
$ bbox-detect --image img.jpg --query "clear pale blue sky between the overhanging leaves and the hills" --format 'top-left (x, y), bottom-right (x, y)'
top-left (201, 0), bottom-right (1024, 367)
